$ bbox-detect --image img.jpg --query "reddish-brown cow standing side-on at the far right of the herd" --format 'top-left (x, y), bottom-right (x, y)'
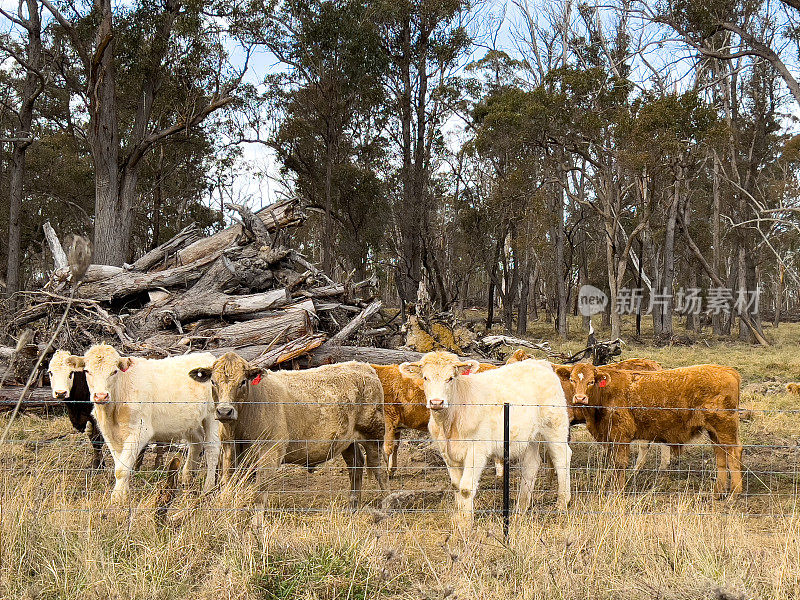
top-left (570, 363), bottom-right (742, 496)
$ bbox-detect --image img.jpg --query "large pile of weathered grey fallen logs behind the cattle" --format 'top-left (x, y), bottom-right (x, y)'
top-left (0, 200), bottom-right (424, 394)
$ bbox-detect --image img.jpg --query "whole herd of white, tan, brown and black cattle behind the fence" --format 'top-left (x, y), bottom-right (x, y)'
top-left (43, 344), bottom-right (742, 518)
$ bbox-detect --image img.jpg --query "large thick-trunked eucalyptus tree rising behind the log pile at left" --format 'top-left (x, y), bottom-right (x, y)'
top-left (37, 0), bottom-right (246, 265)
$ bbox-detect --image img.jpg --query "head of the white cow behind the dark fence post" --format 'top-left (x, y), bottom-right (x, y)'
top-left (399, 352), bottom-right (480, 411)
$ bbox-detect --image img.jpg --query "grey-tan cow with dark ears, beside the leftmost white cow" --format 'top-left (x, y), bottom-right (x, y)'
top-left (189, 352), bottom-right (386, 507)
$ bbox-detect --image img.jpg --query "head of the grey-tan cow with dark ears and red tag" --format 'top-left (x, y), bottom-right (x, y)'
top-left (189, 352), bottom-right (265, 423)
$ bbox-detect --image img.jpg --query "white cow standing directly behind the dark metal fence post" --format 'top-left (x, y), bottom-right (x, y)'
top-left (400, 352), bottom-right (572, 521)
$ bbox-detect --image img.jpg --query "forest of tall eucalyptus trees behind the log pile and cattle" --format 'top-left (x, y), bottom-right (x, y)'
top-left (0, 0), bottom-right (800, 341)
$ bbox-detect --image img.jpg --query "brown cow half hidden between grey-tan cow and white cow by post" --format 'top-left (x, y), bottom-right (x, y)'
top-left (372, 364), bottom-right (496, 477)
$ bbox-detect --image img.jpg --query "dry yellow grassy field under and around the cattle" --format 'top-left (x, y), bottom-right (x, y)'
top-left (0, 325), bottom-right (800, 600)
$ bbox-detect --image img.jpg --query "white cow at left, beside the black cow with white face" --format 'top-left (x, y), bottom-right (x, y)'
top-left (68, 344), bottom-right (220, 504)
